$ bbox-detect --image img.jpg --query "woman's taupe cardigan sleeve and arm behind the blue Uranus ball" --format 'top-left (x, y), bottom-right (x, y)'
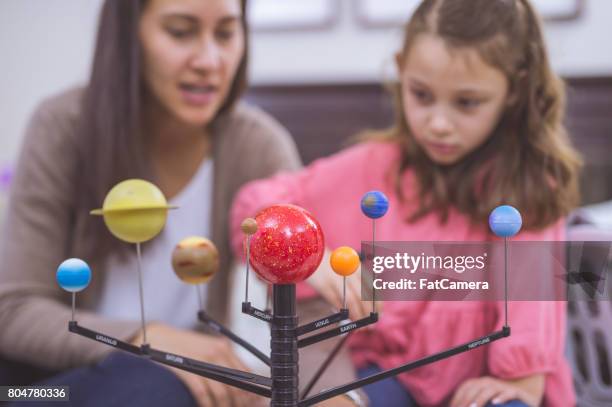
top-left (0, 92), bottom-right (139, 370)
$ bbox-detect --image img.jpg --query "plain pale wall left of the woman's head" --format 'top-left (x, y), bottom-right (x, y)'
top-left (0, 0), bottom-right (101, 167)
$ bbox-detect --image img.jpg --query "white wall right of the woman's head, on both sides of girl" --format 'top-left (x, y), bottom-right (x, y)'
top-left (253, 0), bottom-right (612, 83)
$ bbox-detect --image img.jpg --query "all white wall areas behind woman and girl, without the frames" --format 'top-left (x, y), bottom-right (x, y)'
top-left (0, 0), bottom-right (612, 168)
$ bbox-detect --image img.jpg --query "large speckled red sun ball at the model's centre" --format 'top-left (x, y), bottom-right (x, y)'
top-left (250, 205), bottom-right (325, 284)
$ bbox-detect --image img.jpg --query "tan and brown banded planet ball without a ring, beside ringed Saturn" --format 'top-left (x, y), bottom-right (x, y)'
top-left (172, 236), bottom-right (219, 285)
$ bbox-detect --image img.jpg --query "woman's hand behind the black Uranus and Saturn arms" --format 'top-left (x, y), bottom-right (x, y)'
top-left (132, 323), bottom-right (261, 407)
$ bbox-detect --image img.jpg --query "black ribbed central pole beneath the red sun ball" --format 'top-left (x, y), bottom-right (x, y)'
top-left (270, 284), bottom-right (299, 407)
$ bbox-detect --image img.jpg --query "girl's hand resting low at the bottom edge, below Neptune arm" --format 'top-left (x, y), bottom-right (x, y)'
top-left (450, 374), bottom-right (544, 407)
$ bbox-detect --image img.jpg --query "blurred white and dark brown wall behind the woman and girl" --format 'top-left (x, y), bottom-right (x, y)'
top-left (0, 0), bottom-right (612, 204)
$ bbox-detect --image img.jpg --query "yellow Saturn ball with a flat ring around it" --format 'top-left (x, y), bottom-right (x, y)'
top-left (91, 179), bottom-right (176, 243)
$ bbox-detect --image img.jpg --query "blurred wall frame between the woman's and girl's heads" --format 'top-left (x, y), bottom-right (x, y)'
top-left (247, 0), bottom-right (340, 31)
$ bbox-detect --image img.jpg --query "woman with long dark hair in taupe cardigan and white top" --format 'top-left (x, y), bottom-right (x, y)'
top-left (0, 0), bottom-right (299, 406)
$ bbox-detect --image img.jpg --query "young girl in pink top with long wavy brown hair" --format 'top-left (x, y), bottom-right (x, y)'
top-left (231, 0), bottom-right (579, 407)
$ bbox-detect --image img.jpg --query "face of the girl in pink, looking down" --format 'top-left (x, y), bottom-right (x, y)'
top-left (397, 34), bottom-right (509, 165)
